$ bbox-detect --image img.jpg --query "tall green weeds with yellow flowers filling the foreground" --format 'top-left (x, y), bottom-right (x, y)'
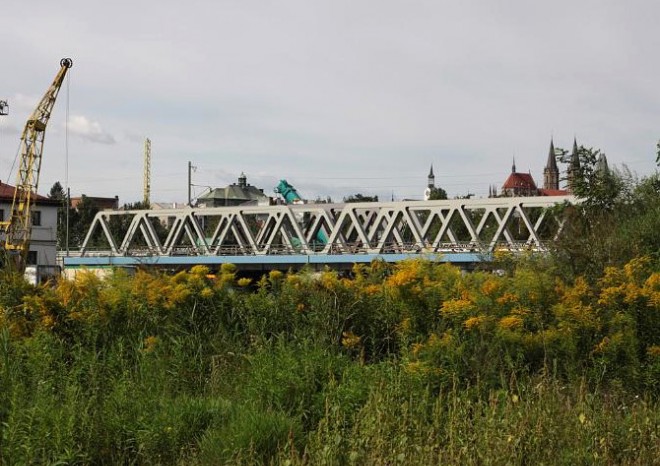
top-left (0, 258), bottom-right (660, 465)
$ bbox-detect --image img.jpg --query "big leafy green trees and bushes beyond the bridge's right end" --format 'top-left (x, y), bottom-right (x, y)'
top-left (553, 147), bottom-right (660, 280)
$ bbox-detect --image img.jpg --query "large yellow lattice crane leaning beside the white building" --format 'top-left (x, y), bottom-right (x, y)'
top-left (0, 58), bottom-right (73, 273)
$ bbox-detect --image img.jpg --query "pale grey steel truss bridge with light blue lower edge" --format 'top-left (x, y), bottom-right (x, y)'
top-left (62, 196), bottom-right (576, 270)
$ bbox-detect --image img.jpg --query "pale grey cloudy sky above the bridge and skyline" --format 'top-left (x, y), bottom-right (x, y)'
top-left (0, 0), bottom-right (660, 204)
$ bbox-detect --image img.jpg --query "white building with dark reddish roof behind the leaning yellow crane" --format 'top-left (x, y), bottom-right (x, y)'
top-left (0, 182), bottom-right (60, 275)
